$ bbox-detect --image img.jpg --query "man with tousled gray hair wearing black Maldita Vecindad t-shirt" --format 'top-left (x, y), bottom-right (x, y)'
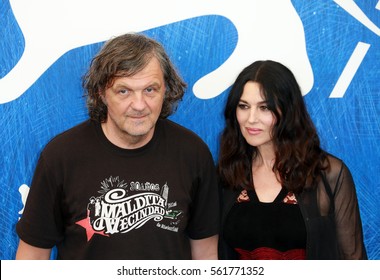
top-left (16, 33), bottom-right (219, 260)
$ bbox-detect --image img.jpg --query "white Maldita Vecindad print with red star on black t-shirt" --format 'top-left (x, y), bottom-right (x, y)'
top-left (76, 176), bottom-right (182, 241)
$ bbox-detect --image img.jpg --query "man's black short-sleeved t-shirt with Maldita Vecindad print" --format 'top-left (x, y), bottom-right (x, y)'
top-left (17, 120), bottom-right (219, 259)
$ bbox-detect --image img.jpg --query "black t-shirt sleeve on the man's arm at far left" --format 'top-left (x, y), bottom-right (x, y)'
top-left (16, 155), bottom-right (62, 248)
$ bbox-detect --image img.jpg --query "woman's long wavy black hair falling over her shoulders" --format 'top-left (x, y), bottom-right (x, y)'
top-left (218, 60), bottom-right (328, 193)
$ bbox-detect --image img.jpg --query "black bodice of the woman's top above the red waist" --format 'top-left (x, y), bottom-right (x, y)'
top-left (223, 189), bottom-right (306, 252)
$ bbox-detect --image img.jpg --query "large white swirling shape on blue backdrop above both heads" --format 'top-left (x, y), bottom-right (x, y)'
top-left (0, 0), bottom-right (313, 103)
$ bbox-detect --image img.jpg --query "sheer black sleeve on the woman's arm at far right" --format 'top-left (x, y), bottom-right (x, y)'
top-left (328, 159), bottom-right (367, 259)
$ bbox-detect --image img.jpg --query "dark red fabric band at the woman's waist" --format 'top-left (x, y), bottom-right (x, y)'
top-left (235, 247), bottom-right (306, 260)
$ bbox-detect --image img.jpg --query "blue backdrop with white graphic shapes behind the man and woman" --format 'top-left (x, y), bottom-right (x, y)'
top-left (0, 0), bottom-right (380, 259)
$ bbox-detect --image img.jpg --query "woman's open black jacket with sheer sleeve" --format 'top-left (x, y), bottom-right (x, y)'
top-left (219, 155), bottom-right (367, 260)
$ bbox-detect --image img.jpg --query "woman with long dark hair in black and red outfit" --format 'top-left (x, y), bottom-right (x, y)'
top-left (218, 60), bottom-right (367, 259)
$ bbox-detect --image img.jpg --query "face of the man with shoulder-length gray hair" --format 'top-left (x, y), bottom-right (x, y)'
top-left (102, 57), bottom-right (166, 149)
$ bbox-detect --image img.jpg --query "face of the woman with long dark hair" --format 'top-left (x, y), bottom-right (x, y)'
top-left (236, 82), bottom-right (276, 148)
